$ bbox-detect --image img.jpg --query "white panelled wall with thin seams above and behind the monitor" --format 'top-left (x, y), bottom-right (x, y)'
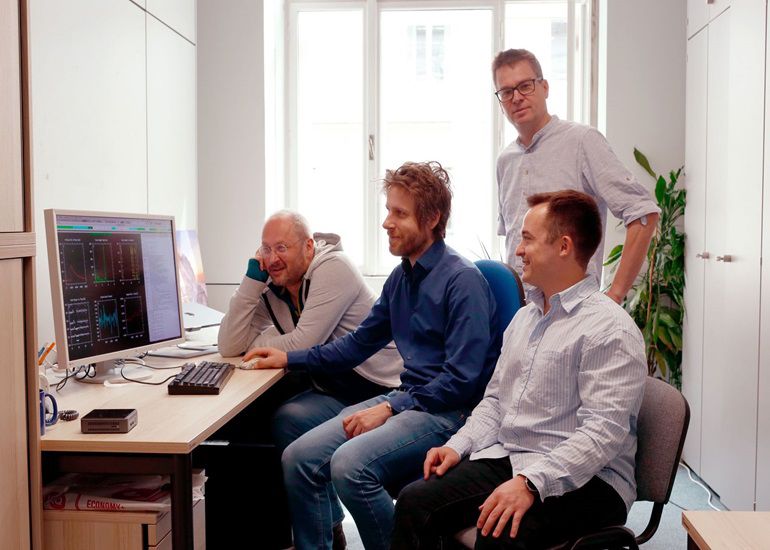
top-left (30, 0), bottom-right (197, 342)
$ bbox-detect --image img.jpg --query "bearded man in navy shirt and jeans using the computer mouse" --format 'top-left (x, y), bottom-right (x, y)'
top-left (246, 162), bottom-right (504, 550)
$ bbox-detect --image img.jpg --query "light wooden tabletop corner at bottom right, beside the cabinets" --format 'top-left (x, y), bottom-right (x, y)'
top-left (682, 511), bottom-right (770, 550)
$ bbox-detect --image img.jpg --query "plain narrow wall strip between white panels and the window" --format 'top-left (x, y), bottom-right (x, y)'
top-left (198, 0), bottom-right (265, 310)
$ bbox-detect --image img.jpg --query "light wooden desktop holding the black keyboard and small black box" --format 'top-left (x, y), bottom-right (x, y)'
top-left (40, 355), bottom-right (284, 454)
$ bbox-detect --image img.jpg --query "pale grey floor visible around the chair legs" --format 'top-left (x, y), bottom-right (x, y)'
top-left (343, 466), bottom-right (725, 550)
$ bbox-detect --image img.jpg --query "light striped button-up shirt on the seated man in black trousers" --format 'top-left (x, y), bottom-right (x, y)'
top-left (447, 276), bottom-right (647, 508)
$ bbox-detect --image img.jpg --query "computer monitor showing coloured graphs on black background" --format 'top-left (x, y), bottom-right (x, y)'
top-left (45, 209), bottom-right (184, 382)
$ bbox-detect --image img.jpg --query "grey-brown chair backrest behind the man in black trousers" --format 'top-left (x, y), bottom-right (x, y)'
top-left (636, 377), bottom-right (690, 504)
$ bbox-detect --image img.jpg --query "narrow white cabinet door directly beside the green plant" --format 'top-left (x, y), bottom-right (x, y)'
top-left (682, 29), bottom-right (708, 472)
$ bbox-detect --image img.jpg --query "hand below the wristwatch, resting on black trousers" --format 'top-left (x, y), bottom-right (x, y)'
top-left (476, 476), bottom-right (535, 538)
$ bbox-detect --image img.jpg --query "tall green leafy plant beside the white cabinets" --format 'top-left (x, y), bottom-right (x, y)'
top-left (604, 148), bottom-right (686, 389)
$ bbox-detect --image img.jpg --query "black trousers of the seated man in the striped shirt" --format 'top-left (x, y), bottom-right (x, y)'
top-left (391, 457), bottom-right (626, 550)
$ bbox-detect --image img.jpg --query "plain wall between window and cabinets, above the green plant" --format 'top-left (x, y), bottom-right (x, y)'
top-left (598, 0), bottom-right (687, 272)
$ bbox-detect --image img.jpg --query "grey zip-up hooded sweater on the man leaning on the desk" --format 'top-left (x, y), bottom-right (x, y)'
top-left (219, 233), bottom-right (404, 388)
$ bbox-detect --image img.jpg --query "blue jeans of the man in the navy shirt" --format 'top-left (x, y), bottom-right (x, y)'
top-left (281, 396), bottom-right (467, 550)
